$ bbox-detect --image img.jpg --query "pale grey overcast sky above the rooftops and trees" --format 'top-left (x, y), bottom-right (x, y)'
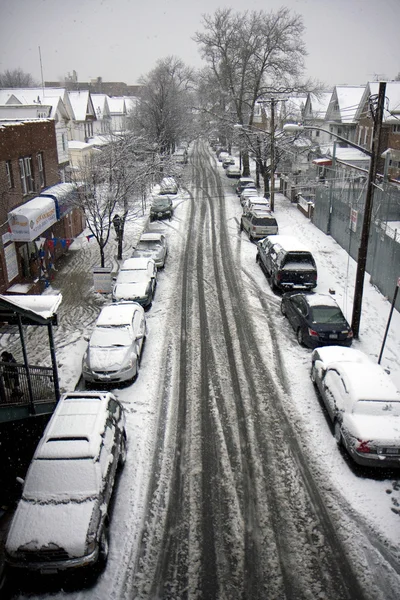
top-left (0, 0), bottom-right (400, 86)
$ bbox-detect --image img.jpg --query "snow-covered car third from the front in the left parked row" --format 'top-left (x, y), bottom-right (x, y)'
top-left (112, 258), bottom-right (157, 308)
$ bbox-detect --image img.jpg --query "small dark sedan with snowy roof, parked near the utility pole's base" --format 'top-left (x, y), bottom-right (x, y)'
top-left (281, 292), bottom-right (353, 348)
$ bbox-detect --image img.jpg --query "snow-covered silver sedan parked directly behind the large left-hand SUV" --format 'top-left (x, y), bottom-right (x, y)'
top-left (82, 302), bottom-right (146, 383)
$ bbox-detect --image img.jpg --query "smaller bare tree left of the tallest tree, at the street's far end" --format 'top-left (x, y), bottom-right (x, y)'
top-left (131, 56), bottom-right (194, 154)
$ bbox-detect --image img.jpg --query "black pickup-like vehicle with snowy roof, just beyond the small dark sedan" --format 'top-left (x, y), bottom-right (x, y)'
top-left (256, 235), bottom-right (317, 291)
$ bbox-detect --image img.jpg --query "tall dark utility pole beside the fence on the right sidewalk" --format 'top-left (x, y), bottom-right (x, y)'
top-left (351, 81), bottom-right (386, 338)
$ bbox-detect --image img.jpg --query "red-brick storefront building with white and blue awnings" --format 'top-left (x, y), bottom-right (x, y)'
top-left (0, 118), bottom-right (85, 294)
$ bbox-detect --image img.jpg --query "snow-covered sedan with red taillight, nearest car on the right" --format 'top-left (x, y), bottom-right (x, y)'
top-left (311, 346), bottom-right (400, 468)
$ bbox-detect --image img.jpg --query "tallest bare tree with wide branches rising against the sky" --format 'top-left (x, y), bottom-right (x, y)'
top-left (194, 8), bottom-right (315, 176)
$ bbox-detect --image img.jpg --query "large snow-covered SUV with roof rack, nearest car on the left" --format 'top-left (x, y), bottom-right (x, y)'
top-left (5, 392), bottom-right (126, 575)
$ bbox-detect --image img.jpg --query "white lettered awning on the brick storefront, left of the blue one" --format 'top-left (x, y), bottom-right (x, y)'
top-left (8, 197), bottom-right (57, 242)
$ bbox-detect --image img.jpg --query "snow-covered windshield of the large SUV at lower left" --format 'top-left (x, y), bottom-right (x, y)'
top-left (23, 460), bottom-right (99, 502)
